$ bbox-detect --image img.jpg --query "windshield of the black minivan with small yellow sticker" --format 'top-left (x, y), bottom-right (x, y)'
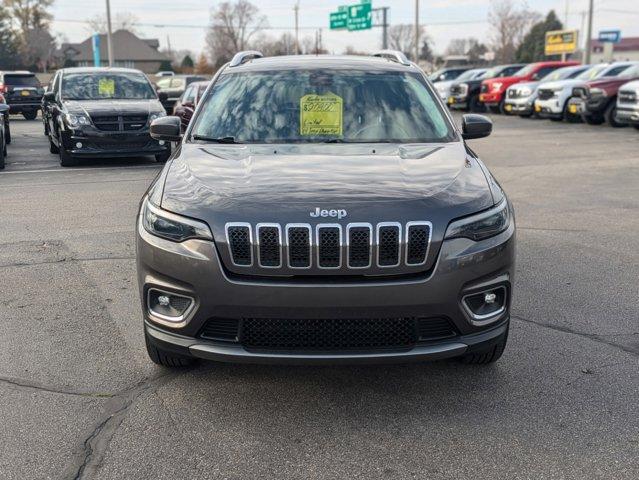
top-left (62, 72), bottom-right (155, 100)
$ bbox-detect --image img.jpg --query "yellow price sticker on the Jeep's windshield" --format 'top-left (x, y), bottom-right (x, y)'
top-left (300, 93), bottom-right (343, 135)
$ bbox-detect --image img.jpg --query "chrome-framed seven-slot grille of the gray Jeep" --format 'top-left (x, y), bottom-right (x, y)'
top-left (225, 221), bottom-right (433, 270)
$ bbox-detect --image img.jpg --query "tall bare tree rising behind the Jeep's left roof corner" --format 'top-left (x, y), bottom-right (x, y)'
top-left (206, 0), bottom-right (267, 66)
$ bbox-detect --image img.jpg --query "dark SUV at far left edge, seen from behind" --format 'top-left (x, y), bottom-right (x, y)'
top-left (0, 71), bottom-right (44, 120)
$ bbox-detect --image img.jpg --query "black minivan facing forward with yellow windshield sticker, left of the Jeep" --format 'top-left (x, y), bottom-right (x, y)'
top-left (42, 67), bottom-right (171, 167)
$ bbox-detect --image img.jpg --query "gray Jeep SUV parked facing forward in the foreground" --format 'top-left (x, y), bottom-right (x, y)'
top-left (137, 51), bottom-right (515, 366)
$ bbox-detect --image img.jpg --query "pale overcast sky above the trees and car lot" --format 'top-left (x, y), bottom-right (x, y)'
top-left (53, 0), bottom-right (639, 53)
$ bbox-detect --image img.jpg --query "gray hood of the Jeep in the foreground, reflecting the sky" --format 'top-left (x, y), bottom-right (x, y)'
top-left (161, 142), bottom-right (494, 244)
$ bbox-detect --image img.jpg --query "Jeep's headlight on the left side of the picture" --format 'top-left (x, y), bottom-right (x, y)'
top-left (142, 198), bottom-right (213, 242)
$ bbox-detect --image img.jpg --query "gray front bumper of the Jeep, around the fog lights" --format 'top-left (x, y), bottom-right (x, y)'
top-left (137, 210), bottom-right (515, 363)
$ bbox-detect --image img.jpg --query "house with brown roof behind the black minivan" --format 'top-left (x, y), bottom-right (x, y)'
top-left (59, 30), bottom-right (170, 74)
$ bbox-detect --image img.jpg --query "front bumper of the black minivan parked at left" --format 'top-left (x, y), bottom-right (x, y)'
top-left (61, 127), bottom-right (171, 158)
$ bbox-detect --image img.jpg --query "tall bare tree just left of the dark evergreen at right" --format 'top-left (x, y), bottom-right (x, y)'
top-left (488, 0), bottom-right (539, 63)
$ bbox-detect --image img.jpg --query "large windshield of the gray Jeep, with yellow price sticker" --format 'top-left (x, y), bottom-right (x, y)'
top-left (192, 69), bottom-right (455, 143)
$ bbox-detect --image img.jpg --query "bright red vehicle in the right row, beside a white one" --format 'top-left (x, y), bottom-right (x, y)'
top-left (479, 61), bottom-right (579, 113)
